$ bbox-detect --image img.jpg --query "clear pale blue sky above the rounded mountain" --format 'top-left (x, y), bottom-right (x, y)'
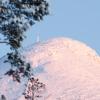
top-left (0, 0), bottom-right (100, 57)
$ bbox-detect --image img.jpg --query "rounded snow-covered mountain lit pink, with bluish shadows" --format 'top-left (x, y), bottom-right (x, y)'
top-left (0, 38), bottom-right (100, 100)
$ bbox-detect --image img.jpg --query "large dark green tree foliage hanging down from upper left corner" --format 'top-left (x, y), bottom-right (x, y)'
top-left (0, 0), bottom-right (49, 82)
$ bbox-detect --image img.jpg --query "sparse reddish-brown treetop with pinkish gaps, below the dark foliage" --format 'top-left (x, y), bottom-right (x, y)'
top-left (24, 77), bottom-right (46, 100)
